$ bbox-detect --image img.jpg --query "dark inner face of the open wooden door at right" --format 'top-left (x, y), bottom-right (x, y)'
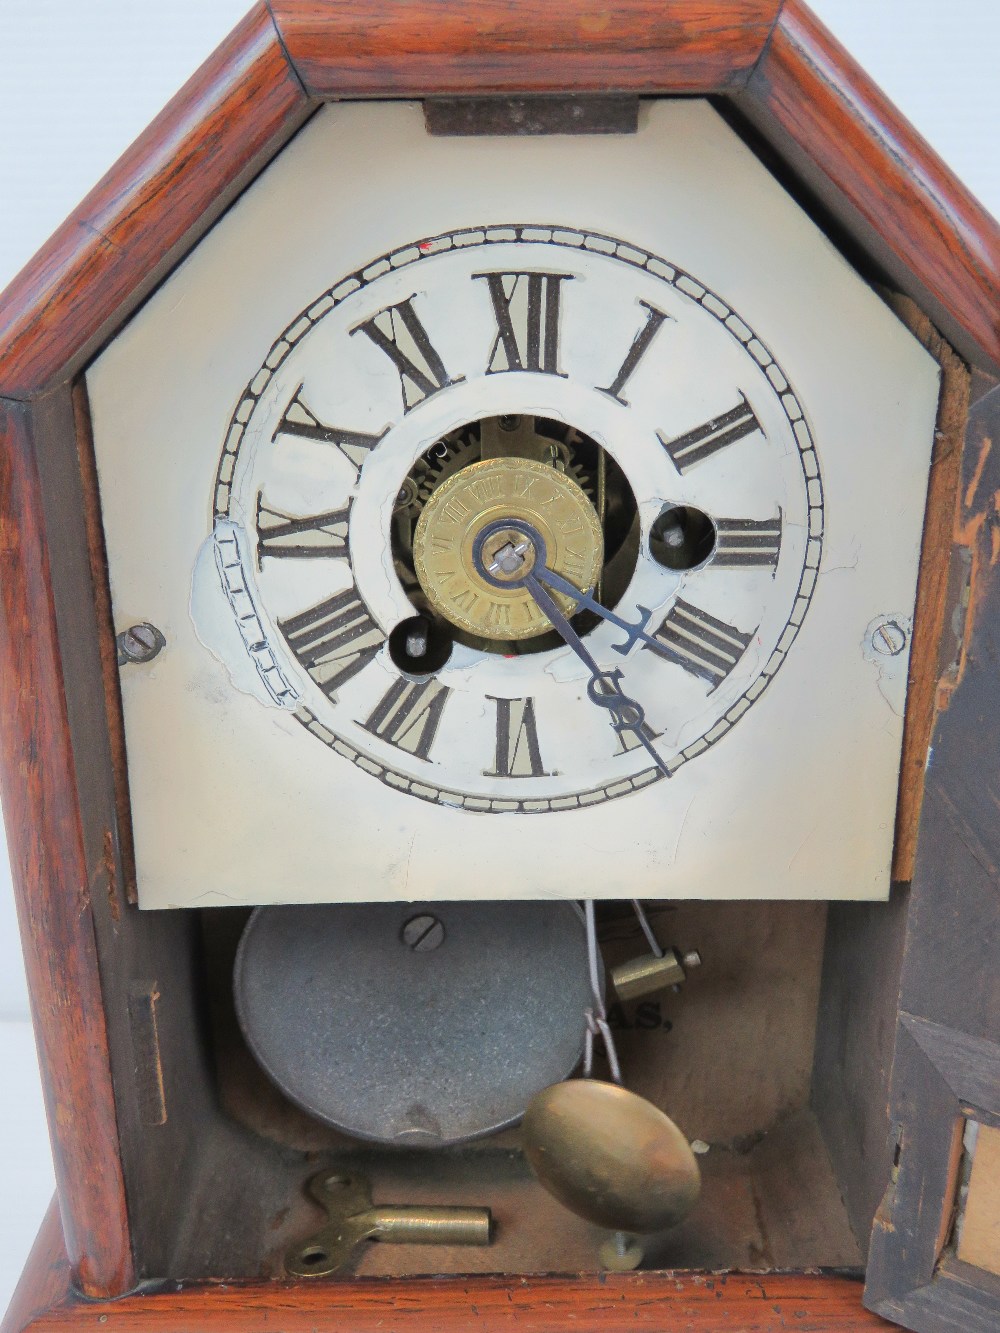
top-left (865, 385), bottom-right (1000, 1333)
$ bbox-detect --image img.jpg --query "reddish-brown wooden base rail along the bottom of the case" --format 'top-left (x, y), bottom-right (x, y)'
top-left (0, 1209), bottom-right (887, 1333)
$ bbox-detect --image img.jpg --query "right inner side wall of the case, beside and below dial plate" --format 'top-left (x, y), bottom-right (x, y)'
top-left (812, 306), bottom-right (971, 1244)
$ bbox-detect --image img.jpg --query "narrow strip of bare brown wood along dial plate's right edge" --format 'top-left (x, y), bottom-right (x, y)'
top-left (888, 296), bottom-right (971, 882)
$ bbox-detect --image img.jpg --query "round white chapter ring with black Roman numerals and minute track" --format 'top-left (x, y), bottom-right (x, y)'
top-left (215, 224), bottom-right (823, 812)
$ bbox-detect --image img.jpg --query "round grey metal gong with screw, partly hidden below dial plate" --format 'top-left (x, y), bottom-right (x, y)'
top-left (235, 902), bottom-right (592, 1146)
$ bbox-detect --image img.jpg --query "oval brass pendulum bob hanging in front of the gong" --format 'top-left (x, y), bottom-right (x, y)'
top-left (523, 1078), bottom-right (701, 1234)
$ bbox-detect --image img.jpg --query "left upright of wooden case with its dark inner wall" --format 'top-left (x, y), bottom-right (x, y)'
top-left (3, 385), bottom-right (230, 1296)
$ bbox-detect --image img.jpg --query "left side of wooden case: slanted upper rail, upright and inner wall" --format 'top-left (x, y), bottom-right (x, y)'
top-left (0, 5), bottom-right (316, 1298)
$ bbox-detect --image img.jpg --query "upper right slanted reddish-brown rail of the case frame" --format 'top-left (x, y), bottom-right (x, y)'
top-left (733, 0), bottom-right (1000, 372)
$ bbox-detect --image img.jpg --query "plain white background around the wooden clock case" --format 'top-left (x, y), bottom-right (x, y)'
top-left (0, 0), bottom-right (1000, 1310)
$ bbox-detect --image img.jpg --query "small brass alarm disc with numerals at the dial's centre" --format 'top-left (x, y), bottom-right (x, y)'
top-left (413, 457), bottom-right (604, 640)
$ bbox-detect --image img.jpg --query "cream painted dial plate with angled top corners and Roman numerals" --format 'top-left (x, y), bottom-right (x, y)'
top-left (87, 100), bottom-right (939, 908)
